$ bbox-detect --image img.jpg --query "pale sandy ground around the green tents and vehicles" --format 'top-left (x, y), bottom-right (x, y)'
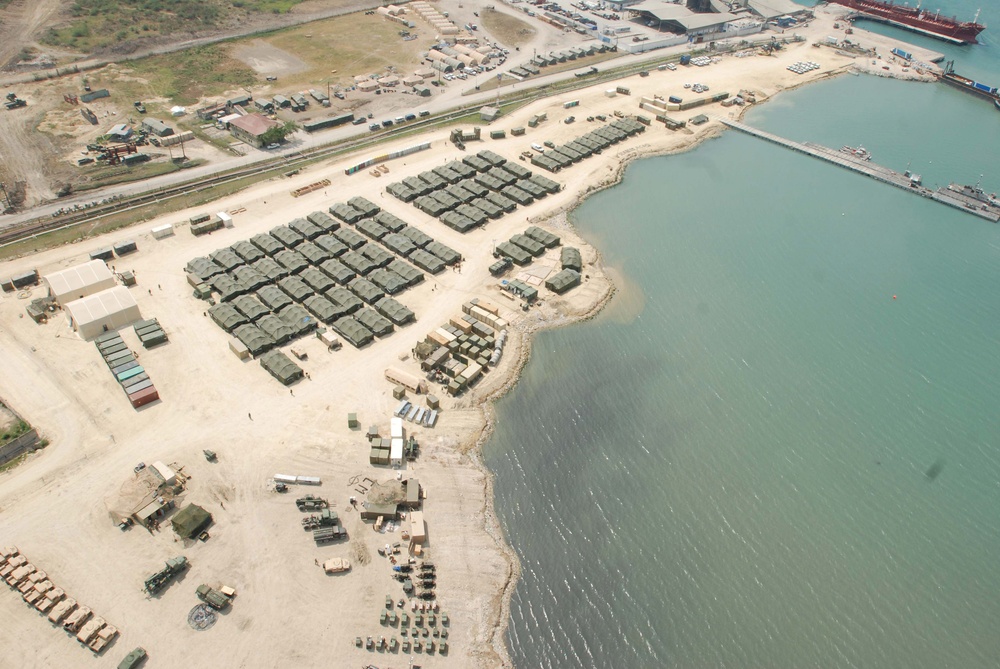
top-left (0, 9), bottom-right (940, 667)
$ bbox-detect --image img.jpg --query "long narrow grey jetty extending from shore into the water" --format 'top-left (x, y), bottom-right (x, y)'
top-left (719, 118), bottom-right (1000, 223)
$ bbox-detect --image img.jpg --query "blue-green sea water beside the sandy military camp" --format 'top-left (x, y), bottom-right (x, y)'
top-left (484, 0), bottom-right (1000, 668)
